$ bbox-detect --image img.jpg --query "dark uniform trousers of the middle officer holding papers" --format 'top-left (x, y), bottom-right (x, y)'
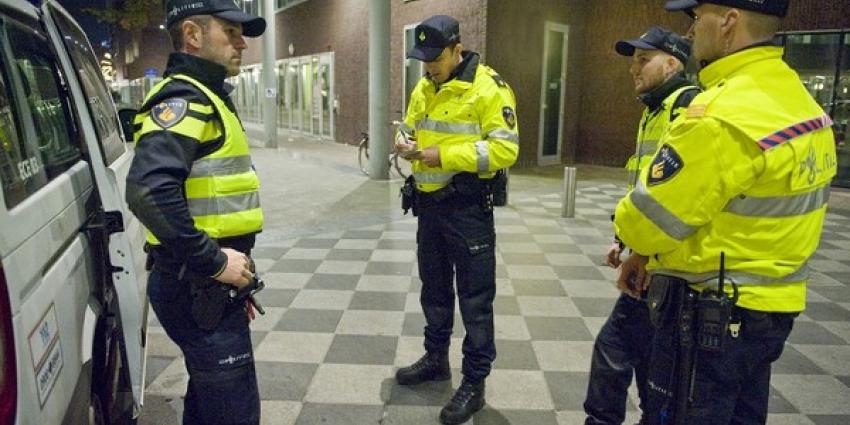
top-left (416, 193), bottom-right (496, 382)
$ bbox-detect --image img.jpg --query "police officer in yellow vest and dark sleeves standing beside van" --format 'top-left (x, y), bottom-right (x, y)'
top-left (127, 0), bottom-right (266, 425)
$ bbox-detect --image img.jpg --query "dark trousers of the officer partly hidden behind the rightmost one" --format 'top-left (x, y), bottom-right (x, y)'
top-left (584, 294), bottom-right (655, 425)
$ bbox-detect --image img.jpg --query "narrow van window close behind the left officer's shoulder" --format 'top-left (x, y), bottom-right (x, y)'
top-left (53, 7), bottom-right (126, 165)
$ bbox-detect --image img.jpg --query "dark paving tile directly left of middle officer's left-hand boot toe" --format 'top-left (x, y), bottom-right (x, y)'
top-left (324, 335), bottom-right (398, 365)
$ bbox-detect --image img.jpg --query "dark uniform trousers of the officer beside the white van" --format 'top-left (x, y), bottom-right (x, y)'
top-left (148, 266), bottom-right (260, 425)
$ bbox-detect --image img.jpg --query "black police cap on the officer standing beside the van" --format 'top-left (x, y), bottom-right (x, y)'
top-left (165, 0), bottom-right (266, 37)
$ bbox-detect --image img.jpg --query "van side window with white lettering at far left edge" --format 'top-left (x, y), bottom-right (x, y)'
top-left (0, 21), bottom-right (81, 208)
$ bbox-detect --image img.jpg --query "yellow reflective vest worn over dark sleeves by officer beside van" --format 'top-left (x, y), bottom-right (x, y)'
top-left (133, 74), bottom-right (263, 245)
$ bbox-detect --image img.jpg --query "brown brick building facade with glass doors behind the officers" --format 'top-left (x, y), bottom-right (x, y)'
top-left (119, 0), bottom-right (850, 186)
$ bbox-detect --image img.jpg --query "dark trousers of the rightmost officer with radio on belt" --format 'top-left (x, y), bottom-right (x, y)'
top-left (646, 288), bottom-right (797, 425)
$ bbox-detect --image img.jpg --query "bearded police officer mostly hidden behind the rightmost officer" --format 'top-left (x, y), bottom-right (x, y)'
top-left (584, 27), bottom-right (699, 425)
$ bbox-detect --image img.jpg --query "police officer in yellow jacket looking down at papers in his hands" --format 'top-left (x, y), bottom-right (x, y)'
top-left (396, 15), bottom-right (519, 424)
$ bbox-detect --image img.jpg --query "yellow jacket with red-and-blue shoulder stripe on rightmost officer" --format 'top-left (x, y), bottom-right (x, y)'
top-left (614, 46), bottom-right (837, 312)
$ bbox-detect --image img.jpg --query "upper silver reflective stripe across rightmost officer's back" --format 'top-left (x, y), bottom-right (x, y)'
top-left (723, 186), bottom-right (829, 217)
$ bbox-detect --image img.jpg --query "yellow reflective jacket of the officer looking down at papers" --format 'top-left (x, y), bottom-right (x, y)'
top-left (401, 52), bottom-right (519, 192)
